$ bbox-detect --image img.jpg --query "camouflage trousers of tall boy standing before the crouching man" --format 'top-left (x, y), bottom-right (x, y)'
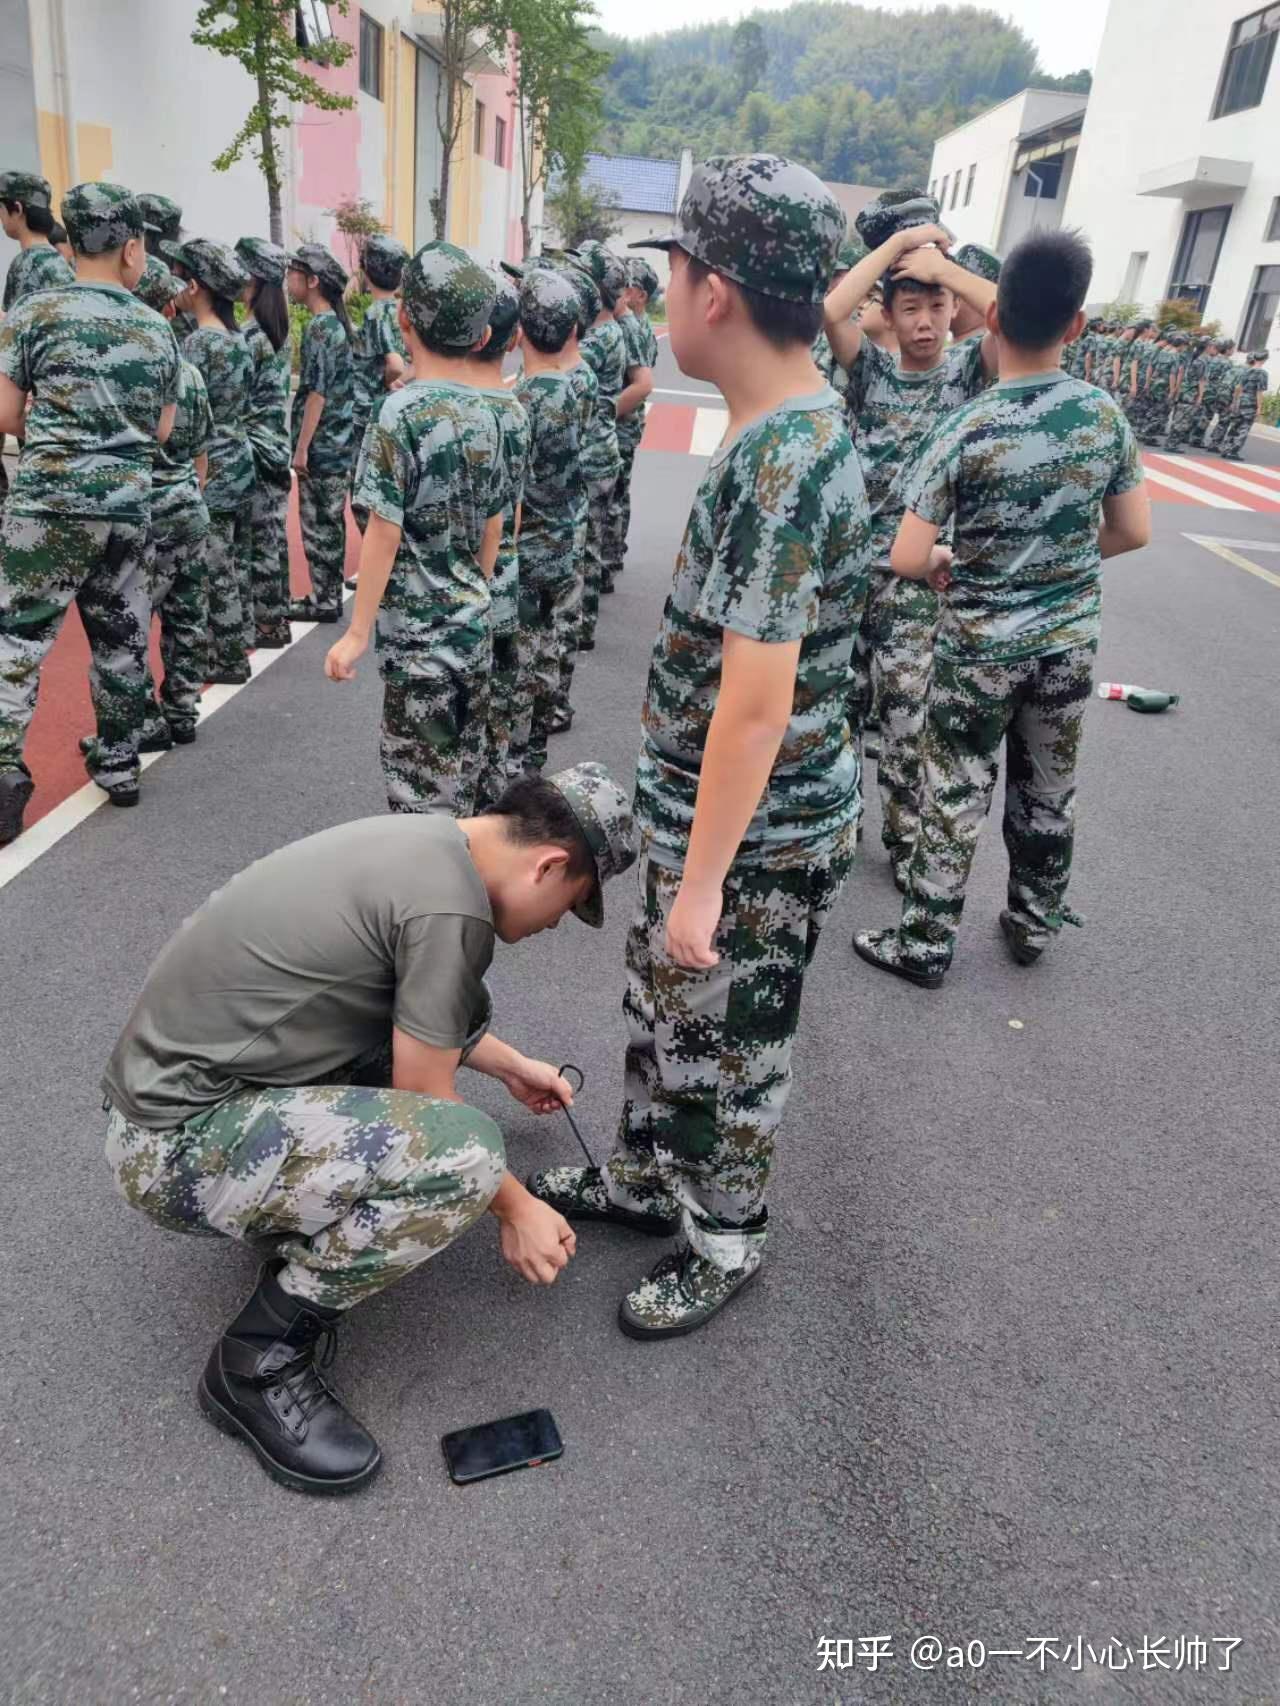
top-left (604, 829), bottom-right (853, 1271)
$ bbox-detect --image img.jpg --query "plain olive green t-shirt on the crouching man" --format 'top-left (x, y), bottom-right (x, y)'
top-left (102, 812), bottom-right (493, 1131)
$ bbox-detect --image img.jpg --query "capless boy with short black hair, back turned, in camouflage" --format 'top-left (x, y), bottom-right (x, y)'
top-left (853, 230), bottom-right (1150, 988)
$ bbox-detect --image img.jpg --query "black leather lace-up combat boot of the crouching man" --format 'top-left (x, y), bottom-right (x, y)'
top-left (196, 1268), bottom-right (382, 1493)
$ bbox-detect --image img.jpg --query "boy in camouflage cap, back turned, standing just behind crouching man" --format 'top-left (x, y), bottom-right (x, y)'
top-left (324, 242), bottom-right (507, 817)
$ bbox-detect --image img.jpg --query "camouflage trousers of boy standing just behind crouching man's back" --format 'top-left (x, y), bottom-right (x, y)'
top-left (379, 644), bottom-right (492, 817)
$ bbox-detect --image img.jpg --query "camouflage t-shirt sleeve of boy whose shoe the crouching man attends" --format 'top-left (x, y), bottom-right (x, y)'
top-left (693, 437), bottom-right (826, 645)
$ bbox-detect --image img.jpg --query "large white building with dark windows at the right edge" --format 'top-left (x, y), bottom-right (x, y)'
top-left (1067, 0), bottom-right (1280, 355)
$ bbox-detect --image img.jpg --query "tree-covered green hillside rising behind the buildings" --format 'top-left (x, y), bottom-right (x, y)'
top-left (599, 0), bottom-right (1089, 184)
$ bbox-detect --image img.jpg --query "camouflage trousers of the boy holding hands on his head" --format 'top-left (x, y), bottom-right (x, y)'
top-left (863, 568), bottom-right (939, 867)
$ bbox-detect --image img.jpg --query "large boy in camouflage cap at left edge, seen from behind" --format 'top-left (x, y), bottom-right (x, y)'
top-left (0, 184), bottom-right (179, 846)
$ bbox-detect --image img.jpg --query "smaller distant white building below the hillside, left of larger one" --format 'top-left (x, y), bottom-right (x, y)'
top-left (928, 89), bottom-right (1087, 254)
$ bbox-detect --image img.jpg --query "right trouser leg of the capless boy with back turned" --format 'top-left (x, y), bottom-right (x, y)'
top-left (1004, 645), bottom-right (1097, 947)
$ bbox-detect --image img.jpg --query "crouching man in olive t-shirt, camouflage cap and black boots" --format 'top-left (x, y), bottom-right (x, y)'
top-left (102, 764), bottom-right (635, 1493)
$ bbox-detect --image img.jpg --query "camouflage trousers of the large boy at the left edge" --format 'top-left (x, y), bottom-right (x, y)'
top-left (0, 505), bottom-right (152, 786)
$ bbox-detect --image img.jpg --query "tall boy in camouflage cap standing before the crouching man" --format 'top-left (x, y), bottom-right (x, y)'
top-left (531, 155), bottom-right (870, 1339)
